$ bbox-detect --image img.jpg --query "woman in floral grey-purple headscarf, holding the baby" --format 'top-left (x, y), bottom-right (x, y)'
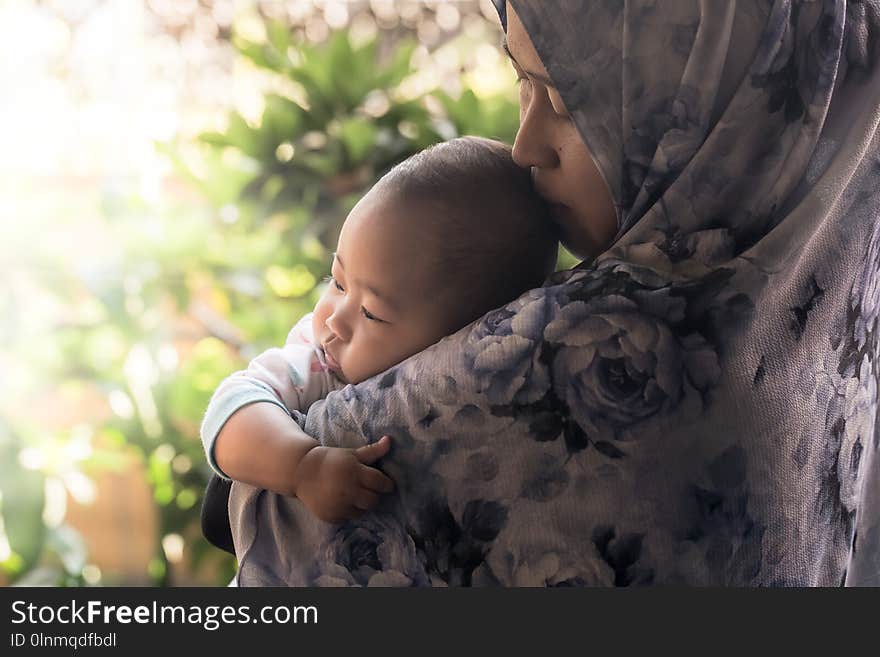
top-left (230, 0), bottom-right (880, 585)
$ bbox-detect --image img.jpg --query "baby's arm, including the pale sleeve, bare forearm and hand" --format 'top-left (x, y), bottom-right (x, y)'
top-left (202, 315), bottom-right (392, 521)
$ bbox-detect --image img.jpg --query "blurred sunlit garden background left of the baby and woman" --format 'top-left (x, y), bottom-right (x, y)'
top-left (0, 0), bottom-right (576, 586)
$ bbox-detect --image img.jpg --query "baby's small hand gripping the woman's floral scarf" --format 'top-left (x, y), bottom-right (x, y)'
top-left (296, 436), bottom-right (394, 523)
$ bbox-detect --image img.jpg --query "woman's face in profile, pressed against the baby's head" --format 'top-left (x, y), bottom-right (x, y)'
top-left (506, 3), bottom-right (617, 259)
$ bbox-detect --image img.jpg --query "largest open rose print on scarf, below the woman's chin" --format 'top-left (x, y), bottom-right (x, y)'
top-left (544, 262), bottom-right (720, 438)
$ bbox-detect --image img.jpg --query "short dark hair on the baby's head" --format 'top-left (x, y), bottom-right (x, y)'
top-left (376, 137), bottom-right (558, 330)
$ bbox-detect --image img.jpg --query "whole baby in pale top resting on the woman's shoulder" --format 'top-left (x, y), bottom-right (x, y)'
top-left (201, 137), bottom-right (557, 522)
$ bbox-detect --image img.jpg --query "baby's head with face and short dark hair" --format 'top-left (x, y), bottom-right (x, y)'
top-left (313, 137), bottom-right (557, 383)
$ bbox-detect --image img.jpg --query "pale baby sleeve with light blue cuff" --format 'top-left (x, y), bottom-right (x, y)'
top-left (200, 313), bottom-right (342, 479)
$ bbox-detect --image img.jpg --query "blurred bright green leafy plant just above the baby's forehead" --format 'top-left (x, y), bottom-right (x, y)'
top-left (195, 23), bottom-right (454, 247)
